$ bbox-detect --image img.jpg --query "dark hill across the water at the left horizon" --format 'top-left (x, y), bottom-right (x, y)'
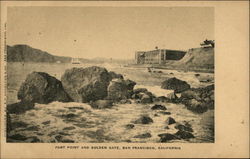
top-left (7, 45), bottom-right (74, 63)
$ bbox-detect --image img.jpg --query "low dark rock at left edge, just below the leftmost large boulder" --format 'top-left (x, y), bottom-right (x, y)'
top-left (7, 101), bottom-right (35, 114)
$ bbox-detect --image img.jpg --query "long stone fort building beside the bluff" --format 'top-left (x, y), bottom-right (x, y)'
top-left (135, 49), bottom-right (186, 64)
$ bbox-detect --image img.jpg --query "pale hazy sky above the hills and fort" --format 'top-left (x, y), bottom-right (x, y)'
top-left (7, 6), bottom-right (214, 59)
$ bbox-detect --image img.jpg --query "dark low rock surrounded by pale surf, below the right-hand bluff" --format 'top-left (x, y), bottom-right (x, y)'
top-left (161, 77), bottom-right (190, 93)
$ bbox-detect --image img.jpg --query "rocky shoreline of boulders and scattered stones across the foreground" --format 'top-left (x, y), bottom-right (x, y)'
top-left (7, 66), bottom-right (214, 142)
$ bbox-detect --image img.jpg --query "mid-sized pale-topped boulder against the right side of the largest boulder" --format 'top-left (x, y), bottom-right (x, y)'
top-left (108, 79), bottom-right (136, 101)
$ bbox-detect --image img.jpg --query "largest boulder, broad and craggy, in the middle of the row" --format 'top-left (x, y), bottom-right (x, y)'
top-left (61, 66), bottom-right (112, 103)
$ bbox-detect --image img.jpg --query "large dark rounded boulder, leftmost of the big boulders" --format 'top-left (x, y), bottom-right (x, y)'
top-left (17, 72), bottom-right (71, 104)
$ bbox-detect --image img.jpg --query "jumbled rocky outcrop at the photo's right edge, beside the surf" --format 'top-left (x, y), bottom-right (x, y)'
top-left (179, 85), bottom-right (214, 113)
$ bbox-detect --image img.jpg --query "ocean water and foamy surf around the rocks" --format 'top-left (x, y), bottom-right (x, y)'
top-left (7, 63), bottom-right (214, 143)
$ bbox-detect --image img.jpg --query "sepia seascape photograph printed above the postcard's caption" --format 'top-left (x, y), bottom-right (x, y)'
top-left (4, 6), bottom-right (215, 143)
